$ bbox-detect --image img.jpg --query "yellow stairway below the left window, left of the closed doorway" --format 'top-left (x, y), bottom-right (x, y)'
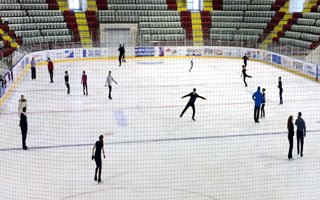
top-left (75, 12), bottom-right (92, 47)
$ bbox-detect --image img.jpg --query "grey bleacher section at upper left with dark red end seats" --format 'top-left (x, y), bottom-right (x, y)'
top-left (0, 0), bottom-right (72, 51)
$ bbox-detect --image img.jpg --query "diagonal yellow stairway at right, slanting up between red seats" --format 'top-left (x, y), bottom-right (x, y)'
top-left (259, 1), bottom-right (292, 50)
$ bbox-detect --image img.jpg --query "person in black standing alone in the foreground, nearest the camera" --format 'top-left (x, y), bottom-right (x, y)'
top-left (91, 135), bottom-right (106, 183)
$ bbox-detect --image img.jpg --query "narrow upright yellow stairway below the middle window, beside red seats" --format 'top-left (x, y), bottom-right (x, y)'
top-left (191, 12), bottom-right (203, 46)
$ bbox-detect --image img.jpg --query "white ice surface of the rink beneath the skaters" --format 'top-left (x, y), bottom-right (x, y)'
top-left (0, 57), bottom-right (320, 200)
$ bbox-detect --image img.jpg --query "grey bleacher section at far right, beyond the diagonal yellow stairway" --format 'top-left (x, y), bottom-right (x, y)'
top-left (273, 10), bottom-right (320, 49)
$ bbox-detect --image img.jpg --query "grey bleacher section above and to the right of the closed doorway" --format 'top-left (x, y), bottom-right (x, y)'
top-left (98, 0), bottom-right (186, 42)
